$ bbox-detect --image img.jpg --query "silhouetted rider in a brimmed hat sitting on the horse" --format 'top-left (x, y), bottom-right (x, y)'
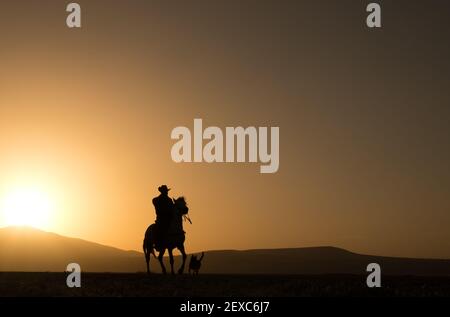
top-left (152, 185), bottom-right (173, 249)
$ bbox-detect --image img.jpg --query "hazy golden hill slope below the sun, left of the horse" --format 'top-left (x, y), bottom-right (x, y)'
top-left (0, 227), bottom-right (144, 272)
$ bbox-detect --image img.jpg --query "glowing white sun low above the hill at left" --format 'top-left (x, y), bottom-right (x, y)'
top-left (0, 188), bottom-right (53, 229)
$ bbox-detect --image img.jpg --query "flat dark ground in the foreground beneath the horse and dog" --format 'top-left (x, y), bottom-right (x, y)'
top-left (0, 273), bottom-right (450, 297)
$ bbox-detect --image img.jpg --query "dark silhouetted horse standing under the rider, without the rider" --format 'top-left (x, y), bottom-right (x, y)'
top-left (143, 197), bottom-right (189, 274)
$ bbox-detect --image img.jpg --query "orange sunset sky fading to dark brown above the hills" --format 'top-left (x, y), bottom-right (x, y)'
top-left (0, 0), bottom-right (450, 258)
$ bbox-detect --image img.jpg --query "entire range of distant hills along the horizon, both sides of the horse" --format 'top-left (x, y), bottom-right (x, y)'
top-left (0, 227), bottom-right (450, 276)
